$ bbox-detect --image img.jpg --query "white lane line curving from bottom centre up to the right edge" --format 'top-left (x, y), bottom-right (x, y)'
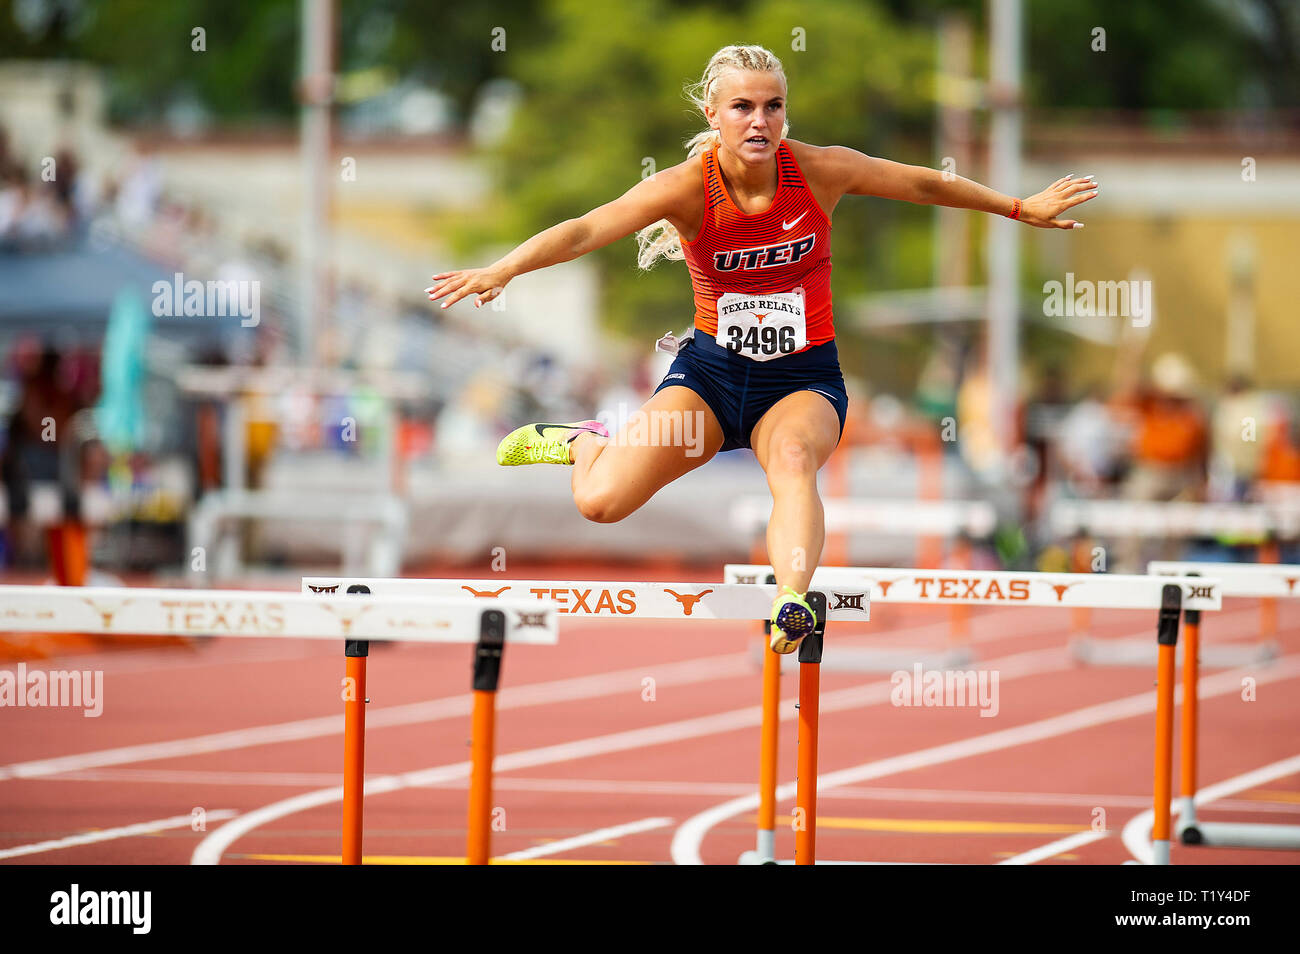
top-left (670, 656), bottom-right (1300, 864)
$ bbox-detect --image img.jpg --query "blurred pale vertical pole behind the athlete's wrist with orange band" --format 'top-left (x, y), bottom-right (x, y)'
top-left (987, 0), bottom-right (1024, 454)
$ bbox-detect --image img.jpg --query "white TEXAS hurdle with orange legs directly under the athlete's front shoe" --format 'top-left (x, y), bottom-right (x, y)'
top-left (303, 577), bottom-right (871, 864)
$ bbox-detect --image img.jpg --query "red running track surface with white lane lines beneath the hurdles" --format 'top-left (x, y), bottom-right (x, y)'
top-left (0, 565), bottom-right (1300, 864)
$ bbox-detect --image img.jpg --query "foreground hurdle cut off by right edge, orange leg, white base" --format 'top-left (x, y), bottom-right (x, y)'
top-left (1147, 560), bottom-right (1300, 851)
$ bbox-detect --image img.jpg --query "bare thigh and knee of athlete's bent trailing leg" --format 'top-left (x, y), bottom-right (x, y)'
top-left (569, 385), bottom-right (723, 524)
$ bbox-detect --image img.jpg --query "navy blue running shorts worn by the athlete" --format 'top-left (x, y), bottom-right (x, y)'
top-left (654, 331), bottom-right (849, 451)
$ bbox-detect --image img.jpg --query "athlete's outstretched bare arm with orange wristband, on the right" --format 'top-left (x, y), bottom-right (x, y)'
top-left (823, 146), bottom-right (1097, 229)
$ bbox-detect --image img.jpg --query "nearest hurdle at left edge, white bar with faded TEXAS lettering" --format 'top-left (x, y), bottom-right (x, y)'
top-left (0, 586), bottom-right (558, 864)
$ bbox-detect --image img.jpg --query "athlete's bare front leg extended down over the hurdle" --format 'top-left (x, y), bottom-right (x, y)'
top-left (750, 391), bottom-right (840, 593)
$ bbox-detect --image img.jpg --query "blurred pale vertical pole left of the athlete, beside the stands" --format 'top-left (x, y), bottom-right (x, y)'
top-left (298, 0), bottom-right (334, 367)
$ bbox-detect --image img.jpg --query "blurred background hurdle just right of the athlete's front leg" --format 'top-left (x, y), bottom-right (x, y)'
top-left (731, 495), bottom-right (997, 672)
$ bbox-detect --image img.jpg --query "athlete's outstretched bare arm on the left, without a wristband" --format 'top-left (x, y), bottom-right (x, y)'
top-left (425, 166), bottom-right (699, 308)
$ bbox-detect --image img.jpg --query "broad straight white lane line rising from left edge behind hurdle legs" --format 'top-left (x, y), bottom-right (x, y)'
top-left (0, 652), bottom-right (754, 780)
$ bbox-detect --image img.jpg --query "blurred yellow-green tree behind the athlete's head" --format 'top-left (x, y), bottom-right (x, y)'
top-left (480, 0), bottom-right (933, 334)
